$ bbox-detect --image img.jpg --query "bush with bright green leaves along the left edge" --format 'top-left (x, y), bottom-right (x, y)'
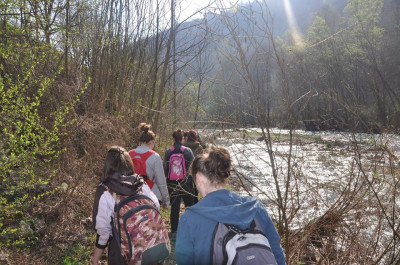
top-left (0, 23), bottom-right (88, 246)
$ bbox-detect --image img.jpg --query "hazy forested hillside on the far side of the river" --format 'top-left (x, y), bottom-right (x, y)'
top-left (178, 0), bottom-right (400, 132)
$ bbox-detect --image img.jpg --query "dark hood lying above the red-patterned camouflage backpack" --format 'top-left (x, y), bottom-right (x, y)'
top-left (103, 173), bottom-right (143, 196)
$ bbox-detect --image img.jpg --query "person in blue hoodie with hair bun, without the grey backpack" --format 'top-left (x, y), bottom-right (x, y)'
top-left (175, 147), bottom-right (286, 265)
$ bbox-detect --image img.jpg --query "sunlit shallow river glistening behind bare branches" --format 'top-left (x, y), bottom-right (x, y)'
top-left (208, 128), bottom-right (400, 261)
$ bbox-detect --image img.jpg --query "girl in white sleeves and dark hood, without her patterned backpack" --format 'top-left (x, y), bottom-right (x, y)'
top-left (92, 146), bottom-right (168, 265)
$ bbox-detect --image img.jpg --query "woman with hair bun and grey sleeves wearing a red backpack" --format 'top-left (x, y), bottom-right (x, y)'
top-left (129, 123), bottom-right (170, 208)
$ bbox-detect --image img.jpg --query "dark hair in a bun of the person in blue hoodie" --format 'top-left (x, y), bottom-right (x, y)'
top-left (191, 146), bottom-right (232, 184)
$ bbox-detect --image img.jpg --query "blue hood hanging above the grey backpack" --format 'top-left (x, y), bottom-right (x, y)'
top-left (187, 189), bottom-right (261, 229)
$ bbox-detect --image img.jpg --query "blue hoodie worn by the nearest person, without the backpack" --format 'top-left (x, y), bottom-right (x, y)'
top-left (175, 189), bottom-right (286, 265)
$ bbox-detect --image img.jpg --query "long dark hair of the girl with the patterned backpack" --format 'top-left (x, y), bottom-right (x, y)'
top-left (103, 146), bottom-right (134, 180)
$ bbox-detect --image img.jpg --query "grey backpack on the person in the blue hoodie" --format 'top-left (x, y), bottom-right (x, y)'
top-left (210, 219), bottom-right (277, 265)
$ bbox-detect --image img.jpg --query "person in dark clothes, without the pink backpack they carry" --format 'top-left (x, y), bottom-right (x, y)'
top-left (163, 129), bottom-right (194, 237)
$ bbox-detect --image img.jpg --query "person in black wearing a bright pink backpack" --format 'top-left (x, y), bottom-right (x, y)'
top-left (164, 129), bottom-right (194, 238)
